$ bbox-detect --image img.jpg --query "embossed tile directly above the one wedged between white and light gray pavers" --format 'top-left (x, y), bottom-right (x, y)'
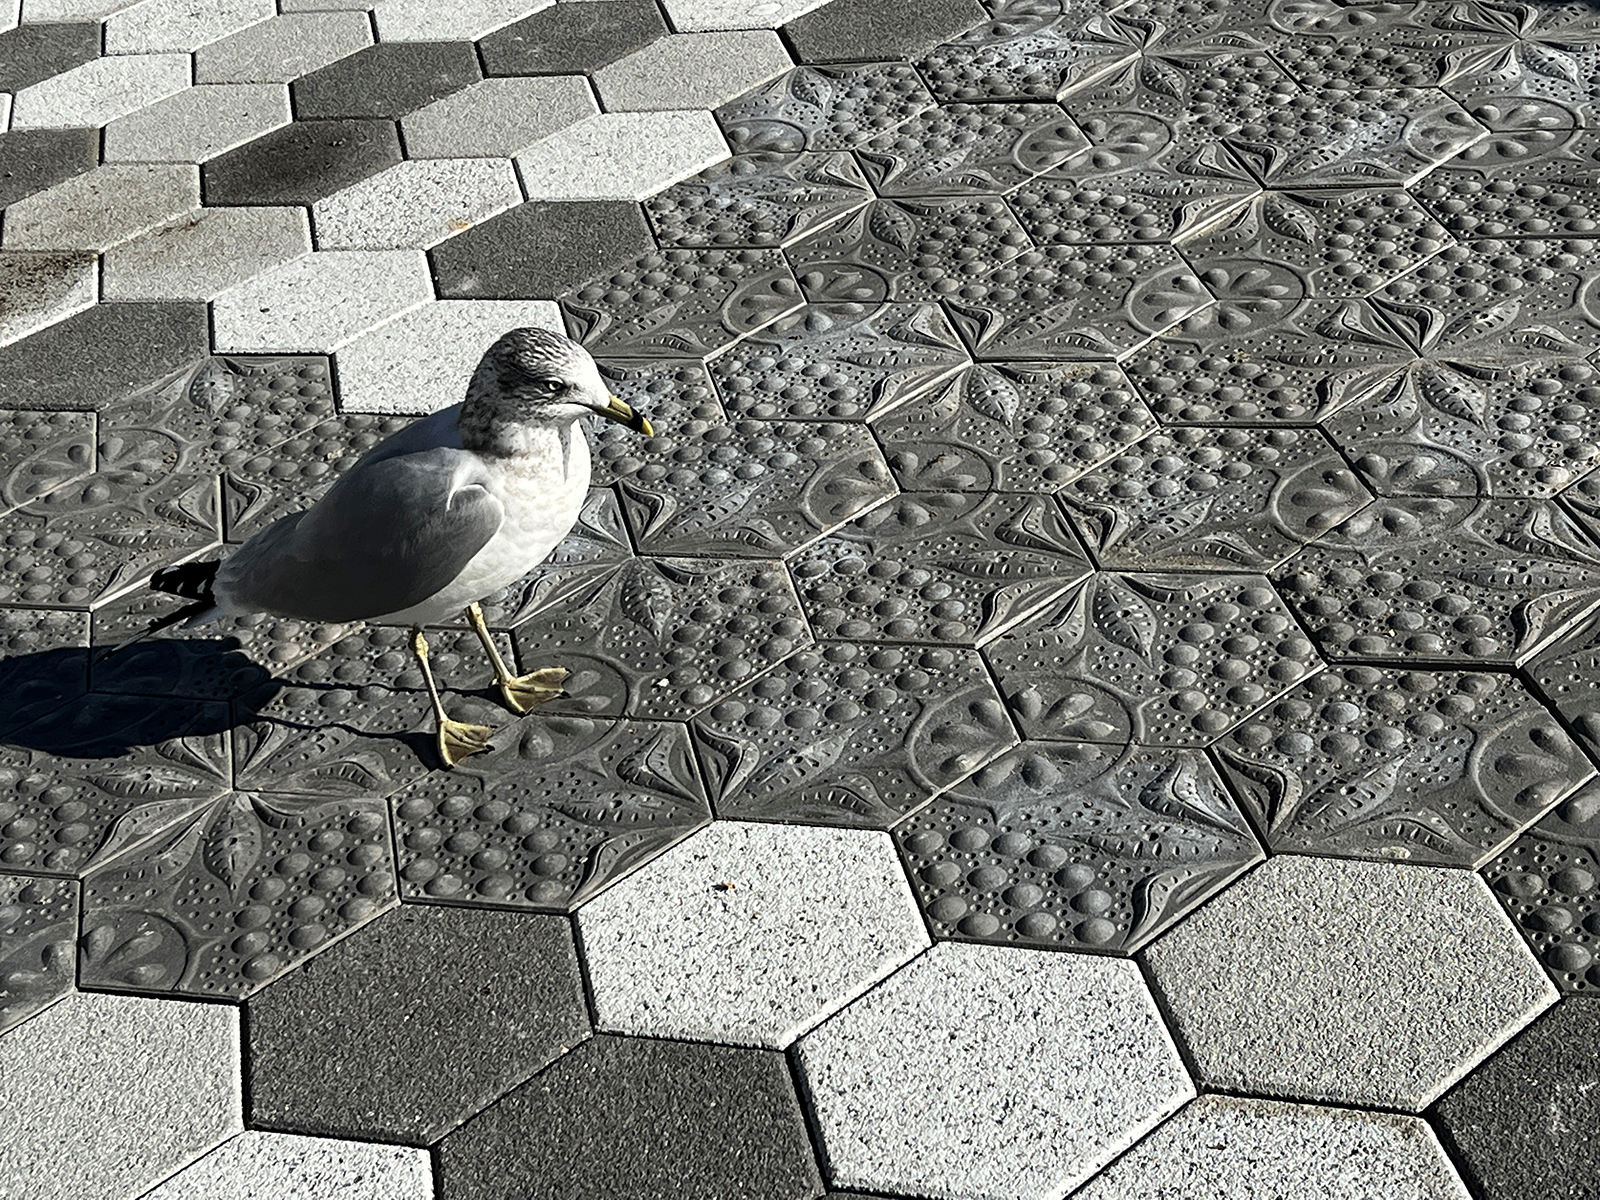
top-left (984, 573), bottom-right (1322, 746)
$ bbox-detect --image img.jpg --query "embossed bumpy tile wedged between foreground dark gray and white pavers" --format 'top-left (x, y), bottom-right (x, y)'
top-left (390, 720), bottom-right (710, 912)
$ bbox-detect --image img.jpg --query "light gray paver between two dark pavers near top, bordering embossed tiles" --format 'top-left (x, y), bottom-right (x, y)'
top-left (595, 29), bottom-right (794, 112)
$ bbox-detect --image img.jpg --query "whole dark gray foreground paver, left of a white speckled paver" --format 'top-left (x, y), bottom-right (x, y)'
top-left (246, 906), bottom-right (589, 1144)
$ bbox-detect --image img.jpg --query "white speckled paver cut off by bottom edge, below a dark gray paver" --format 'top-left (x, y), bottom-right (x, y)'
top-left (144, 1130), bottom-right (434, 1200)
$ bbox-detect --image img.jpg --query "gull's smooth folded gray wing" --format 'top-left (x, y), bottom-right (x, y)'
top-left (216, 446), bottom-right (506, 621)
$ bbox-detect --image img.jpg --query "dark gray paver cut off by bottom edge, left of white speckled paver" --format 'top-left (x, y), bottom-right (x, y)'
top-left (438, 1035), bottom-right (821, 1200)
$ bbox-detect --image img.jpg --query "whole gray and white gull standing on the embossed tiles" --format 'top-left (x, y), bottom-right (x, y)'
top-left (114, 328), bottom-right (654, 766)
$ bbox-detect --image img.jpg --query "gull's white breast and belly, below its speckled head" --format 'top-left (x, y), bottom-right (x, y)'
top-left (378, 424), bottom-right (589, 626)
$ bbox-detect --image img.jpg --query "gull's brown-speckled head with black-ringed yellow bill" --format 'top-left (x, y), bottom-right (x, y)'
top-left (467, 326), bottom-right (654, 437)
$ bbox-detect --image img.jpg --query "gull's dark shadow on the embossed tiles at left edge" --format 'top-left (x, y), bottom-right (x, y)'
top-left (0, 637), bottom-right (283, 758)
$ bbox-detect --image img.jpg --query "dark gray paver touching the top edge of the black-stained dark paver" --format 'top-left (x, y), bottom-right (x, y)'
top-left (290, 42), bottom-right (483, 120)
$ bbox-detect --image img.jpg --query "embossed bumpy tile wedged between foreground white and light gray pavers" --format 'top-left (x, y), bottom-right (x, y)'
top-left (894, 742), bottom-right (1261, 950)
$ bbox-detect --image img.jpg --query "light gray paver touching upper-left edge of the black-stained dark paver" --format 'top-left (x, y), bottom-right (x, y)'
top-left (106, 83), bottom-right (291, 163)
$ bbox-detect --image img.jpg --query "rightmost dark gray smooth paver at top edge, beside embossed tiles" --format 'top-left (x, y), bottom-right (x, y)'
top-left (782, 0), bottom-right (989, 62)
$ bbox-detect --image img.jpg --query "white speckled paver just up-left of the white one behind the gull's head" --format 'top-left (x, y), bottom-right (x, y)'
top-left (211, 250), bottom-right (434, 354)
